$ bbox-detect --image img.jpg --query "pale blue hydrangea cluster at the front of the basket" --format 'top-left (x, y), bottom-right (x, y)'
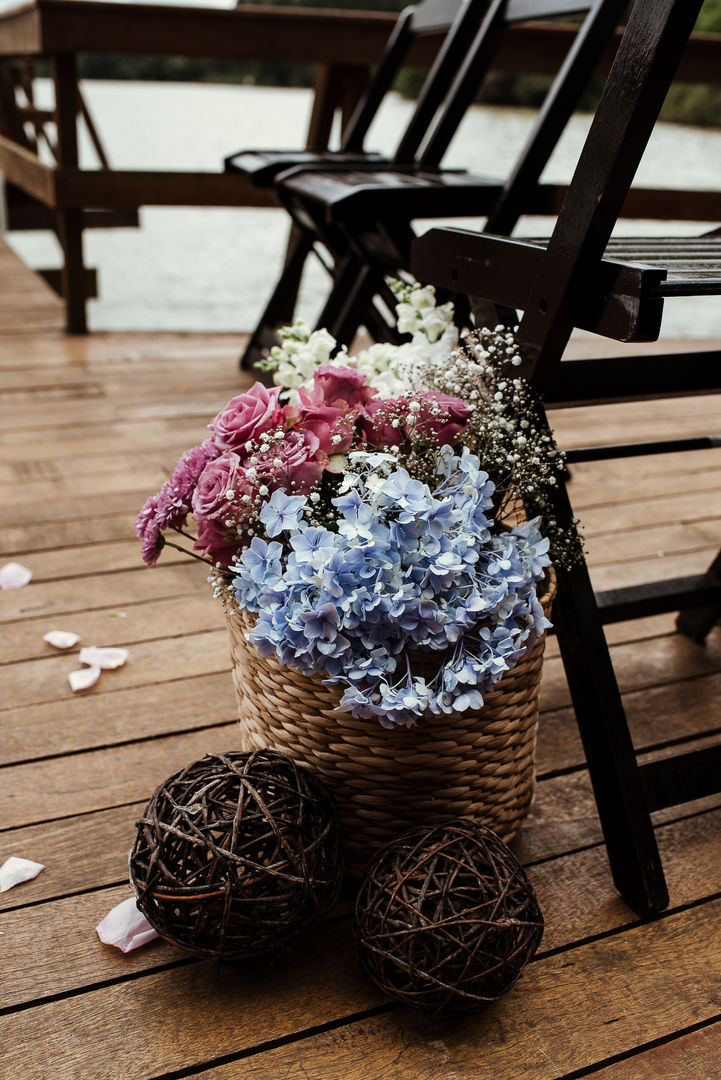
top-left (233, 446), bottom-right (550, 727)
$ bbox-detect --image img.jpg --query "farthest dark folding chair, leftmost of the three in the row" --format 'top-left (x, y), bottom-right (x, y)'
top-left (223, 0), bottom-right (488, 367)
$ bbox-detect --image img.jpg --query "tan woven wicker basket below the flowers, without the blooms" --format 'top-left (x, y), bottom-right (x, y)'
top-left (228, 571), bottom-right (556, 876)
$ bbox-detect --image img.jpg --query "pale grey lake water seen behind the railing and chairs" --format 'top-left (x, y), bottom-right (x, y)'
top-left (9, 80), bottom-right (721, 337)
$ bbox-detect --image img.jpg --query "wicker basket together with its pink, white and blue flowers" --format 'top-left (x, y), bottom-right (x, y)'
top-left (137, 283), bottom-right (563, 869)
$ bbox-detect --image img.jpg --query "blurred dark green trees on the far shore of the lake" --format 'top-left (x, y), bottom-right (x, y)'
top-left (74, 0), bottom-right (721, 126)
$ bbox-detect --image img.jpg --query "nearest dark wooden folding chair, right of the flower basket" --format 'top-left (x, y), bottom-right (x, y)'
top-left (412, 0), bottom-right (721, 914)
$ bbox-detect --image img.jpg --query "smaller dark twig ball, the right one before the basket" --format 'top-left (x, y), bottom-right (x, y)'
top-left (355, 821), bottom-right (543, 1012)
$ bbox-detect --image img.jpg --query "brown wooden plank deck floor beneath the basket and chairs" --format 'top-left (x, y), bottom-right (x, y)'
top-left (0, 251), bottom-right (721, 1080)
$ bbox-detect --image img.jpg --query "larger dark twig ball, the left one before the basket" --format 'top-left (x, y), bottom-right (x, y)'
top-left (130, 751), bottom-right (342, 960)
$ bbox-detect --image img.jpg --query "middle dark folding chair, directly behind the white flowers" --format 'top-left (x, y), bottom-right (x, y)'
top-left (244, 0), bottom-right (625, 364)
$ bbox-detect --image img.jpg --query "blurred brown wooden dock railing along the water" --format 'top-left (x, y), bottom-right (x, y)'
top-left (0, 0), bottom-right (721, 333)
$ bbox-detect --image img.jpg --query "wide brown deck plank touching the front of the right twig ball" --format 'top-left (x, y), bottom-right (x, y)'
top-left (181, 902), bottom-right (719, 1080)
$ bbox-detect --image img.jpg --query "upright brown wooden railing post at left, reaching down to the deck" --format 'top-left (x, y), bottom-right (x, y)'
top-left (52, 53), bottom-right (87, 334)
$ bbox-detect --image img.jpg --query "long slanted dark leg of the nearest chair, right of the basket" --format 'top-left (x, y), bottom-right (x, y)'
top-left (546, 488), bottom-right (668, 916)
